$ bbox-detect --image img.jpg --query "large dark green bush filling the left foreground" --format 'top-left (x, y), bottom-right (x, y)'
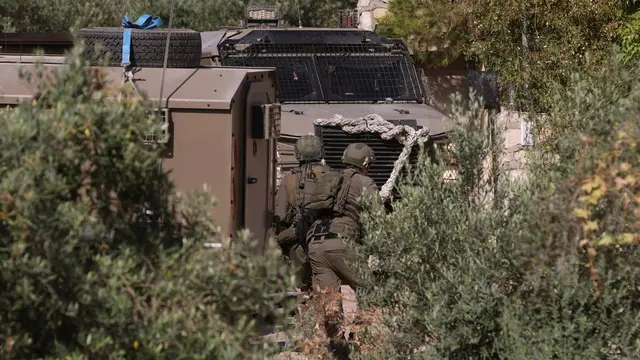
top-left (0, 48), bottom-right (293, 359)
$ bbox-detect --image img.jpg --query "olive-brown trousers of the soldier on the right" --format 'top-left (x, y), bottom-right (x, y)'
top-left (309, 234), bottom-right (360, 291)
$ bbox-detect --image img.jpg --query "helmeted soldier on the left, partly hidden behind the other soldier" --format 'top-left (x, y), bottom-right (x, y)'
top-left (275, 135), bottom-right (330, 291)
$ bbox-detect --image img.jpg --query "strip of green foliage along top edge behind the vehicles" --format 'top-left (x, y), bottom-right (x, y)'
top-left (0, 0), bottom-right (356, 32)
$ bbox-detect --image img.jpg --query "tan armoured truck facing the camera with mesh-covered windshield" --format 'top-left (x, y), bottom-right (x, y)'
top-left (201, 5), bottom-right (456, 193)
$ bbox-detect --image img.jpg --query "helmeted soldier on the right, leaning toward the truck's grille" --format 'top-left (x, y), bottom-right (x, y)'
top-left (308, 143), bottom-right (380, 304)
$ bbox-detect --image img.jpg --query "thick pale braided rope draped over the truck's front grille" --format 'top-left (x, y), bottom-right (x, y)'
top-left (313, 114), bottom-right (429, 200)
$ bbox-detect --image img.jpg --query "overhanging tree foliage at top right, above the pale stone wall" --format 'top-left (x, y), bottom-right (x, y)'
top-left (384, 0), bottom-right (625, 111)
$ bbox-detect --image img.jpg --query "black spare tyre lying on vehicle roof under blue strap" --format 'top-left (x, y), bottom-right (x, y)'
top-left (76, 27), bottom-right (202, 68)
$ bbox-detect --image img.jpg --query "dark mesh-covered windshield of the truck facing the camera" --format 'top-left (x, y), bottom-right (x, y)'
top-left (219, 30), bottom-right (421, 103)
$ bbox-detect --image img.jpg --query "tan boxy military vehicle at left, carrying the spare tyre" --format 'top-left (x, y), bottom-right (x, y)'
top-left (0, 45), bottom-right (280, 250)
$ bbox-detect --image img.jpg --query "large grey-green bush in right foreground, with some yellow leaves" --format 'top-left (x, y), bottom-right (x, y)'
top-left (356, 50), bottom-right (640, 360)
